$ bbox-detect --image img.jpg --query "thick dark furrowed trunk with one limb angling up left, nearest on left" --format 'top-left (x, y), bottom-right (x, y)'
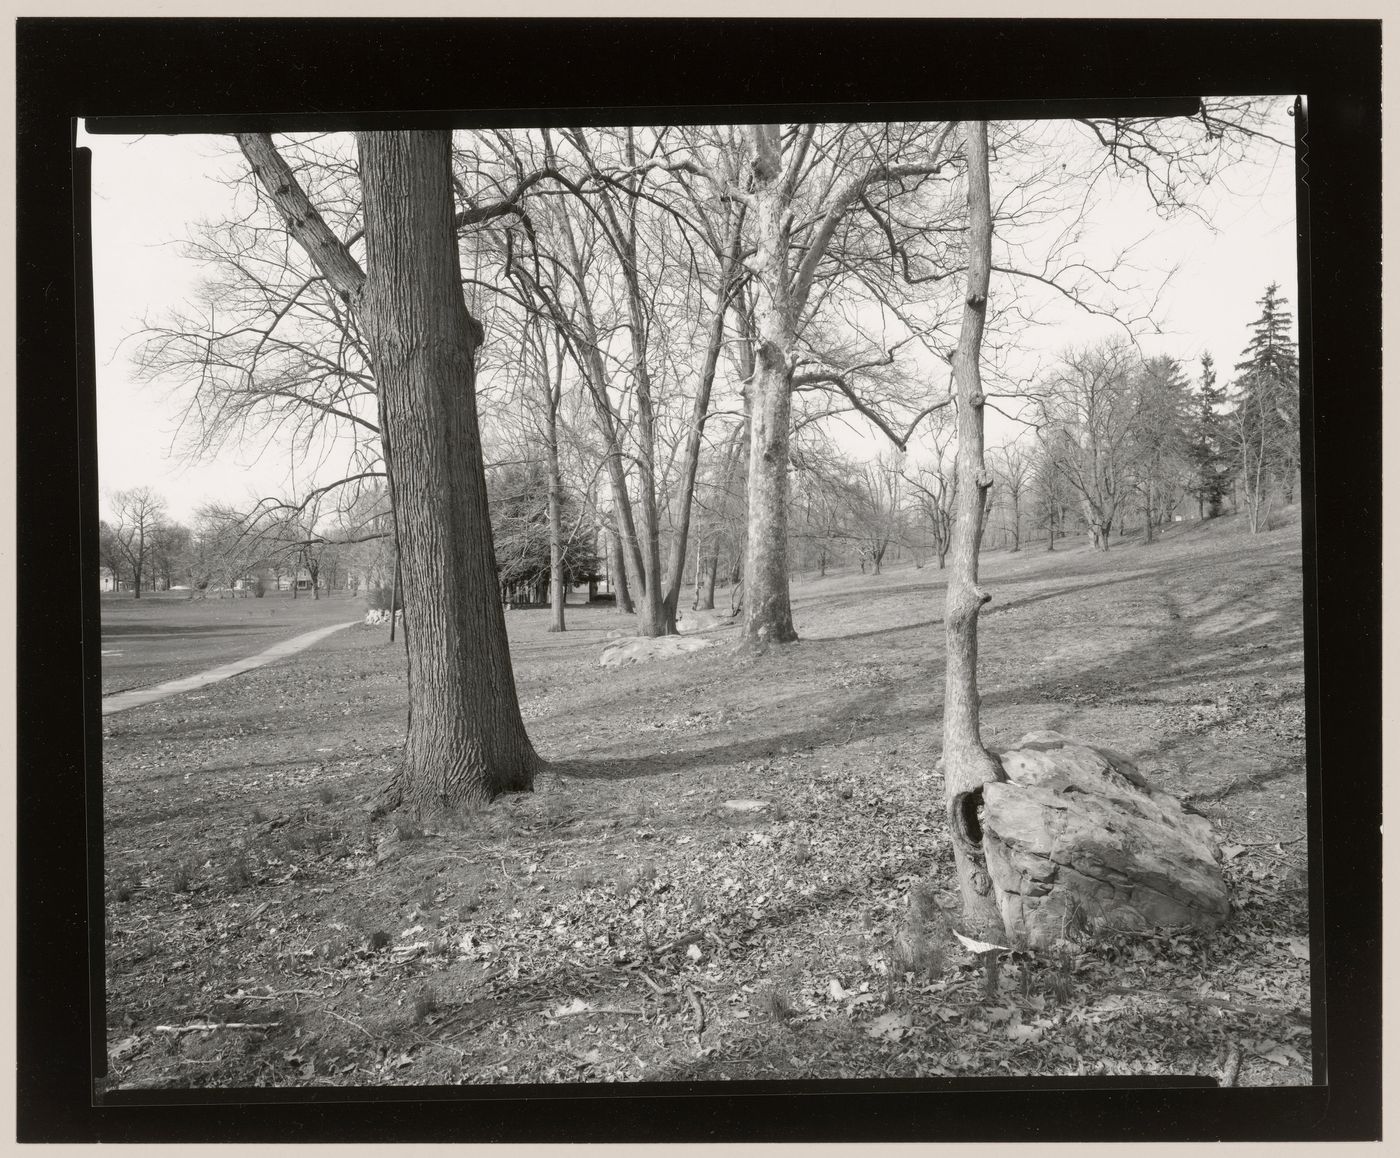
top-left (238, 132), bottom-right (540, 816)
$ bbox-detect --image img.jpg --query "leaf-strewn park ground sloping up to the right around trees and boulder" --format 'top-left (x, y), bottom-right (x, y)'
top-left (104, 519), bottom-right (1312, 1088)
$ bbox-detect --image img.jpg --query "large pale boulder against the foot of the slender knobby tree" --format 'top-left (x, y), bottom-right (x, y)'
top-left (981, 731), bottom-right (1229, 948)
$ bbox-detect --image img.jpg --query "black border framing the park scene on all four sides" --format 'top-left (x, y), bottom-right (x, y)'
top-left (15, 18), bottom-right (1380, 1143)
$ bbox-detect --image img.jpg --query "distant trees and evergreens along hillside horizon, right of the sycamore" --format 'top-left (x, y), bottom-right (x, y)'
top-left (767, 284), bottom-right (1301, 575)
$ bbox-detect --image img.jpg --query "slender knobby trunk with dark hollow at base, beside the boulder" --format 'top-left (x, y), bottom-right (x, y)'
top-left (942, 120), bottom-right (1005, 941)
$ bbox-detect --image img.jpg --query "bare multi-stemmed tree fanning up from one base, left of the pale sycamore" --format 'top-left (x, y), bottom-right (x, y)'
top-left (492, 129), bottom-right (742, 644)
